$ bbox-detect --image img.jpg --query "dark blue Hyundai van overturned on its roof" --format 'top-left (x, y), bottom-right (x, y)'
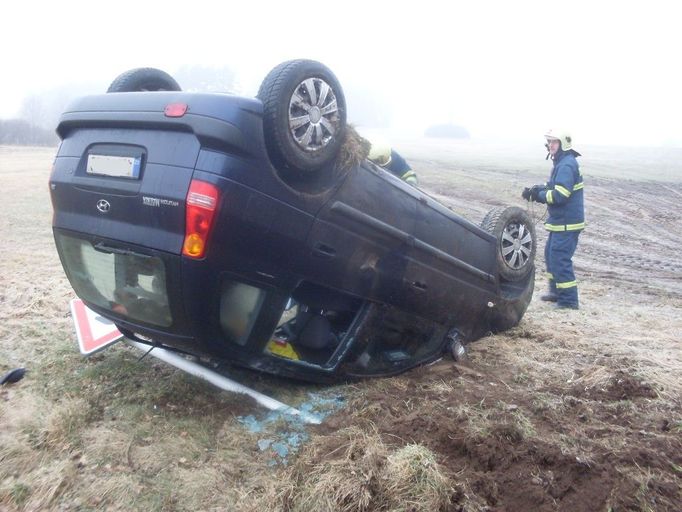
top-left (50, 60), bottom-right (536, 382)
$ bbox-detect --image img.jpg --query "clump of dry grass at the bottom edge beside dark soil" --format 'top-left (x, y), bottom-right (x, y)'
top-left (278, 427), bottom-right (453, 512)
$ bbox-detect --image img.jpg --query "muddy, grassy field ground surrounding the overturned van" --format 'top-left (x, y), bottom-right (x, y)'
top-left (0, 142), bottom-right (682, 511)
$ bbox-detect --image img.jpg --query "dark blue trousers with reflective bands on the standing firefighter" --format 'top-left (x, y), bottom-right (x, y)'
top-left (545, 231), bottom-right (580, 306)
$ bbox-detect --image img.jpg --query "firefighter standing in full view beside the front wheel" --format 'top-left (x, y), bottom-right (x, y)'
top-left (521, 130), bottom-right (585, 309)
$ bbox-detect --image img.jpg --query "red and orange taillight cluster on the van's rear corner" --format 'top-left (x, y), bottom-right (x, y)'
top-left (182, 180), bottom-right (220, 258)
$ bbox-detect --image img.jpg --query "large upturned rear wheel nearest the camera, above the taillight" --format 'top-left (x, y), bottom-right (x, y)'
top-left (258, 59), bottom-right (346, 174)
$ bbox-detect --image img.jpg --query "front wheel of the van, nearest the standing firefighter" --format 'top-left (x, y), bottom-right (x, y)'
top-left (481, 206), bottom-right (537, 282)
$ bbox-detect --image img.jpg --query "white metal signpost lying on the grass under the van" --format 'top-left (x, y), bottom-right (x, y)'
top-left (126, 338), bottom-right (320, 425)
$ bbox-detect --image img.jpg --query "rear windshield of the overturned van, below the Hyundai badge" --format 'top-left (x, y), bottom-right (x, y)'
top-left (55, 233), bottom-right (173, 327)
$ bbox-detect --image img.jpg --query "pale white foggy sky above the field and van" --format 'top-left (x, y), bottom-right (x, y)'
top-left (0, 0), bottom-right (682, 146)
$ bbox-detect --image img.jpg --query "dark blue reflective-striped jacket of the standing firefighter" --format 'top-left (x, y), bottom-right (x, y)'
top-left (537, 151), bottom-right (585, 231)
